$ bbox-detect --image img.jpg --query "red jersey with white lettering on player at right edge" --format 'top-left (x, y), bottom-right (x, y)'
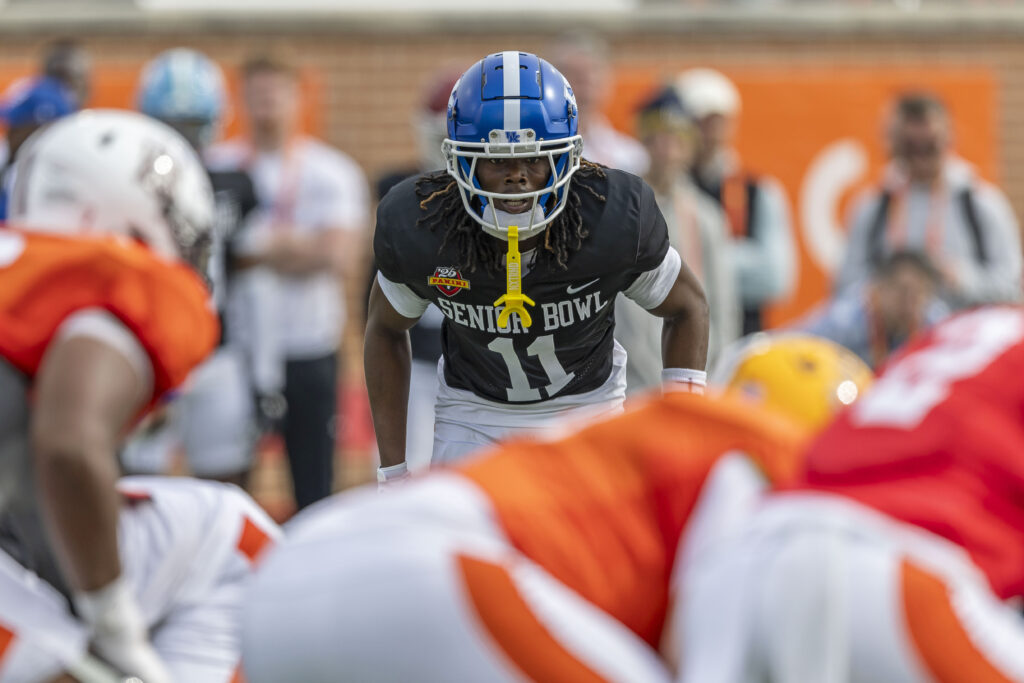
top-left (799, 306), bottom-right (1024, 598)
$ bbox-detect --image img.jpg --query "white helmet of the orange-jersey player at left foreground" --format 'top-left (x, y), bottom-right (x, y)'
top-left (8, 110), bottom-right (214, 271)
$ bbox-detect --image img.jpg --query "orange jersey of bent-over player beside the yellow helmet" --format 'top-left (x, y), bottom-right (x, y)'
top-left (459, 393), bottom-right (807, 647)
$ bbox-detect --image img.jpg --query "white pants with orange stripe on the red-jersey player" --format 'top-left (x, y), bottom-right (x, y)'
top-left (682, 494), bottom-right (1024, 683)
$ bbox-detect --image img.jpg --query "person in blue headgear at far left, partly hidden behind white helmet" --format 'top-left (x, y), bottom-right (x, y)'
top-left (0, 77), bottom-right (76, 220)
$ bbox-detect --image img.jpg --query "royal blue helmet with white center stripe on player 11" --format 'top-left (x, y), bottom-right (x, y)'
top-left (441, 51), bottom-right (583, 240)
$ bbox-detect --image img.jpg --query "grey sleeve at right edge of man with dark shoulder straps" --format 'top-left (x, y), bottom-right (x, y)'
top-left (957, 183), bottom-right (1022, 304)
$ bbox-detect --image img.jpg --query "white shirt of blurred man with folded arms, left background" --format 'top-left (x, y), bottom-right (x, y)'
top-left (207, 137), bottom-right (369, 359)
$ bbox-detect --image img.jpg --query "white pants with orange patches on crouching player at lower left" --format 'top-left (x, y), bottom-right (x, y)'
top-left (0, 477), bottom-right (280, 683)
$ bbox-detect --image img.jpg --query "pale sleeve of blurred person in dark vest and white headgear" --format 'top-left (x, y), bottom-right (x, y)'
top-left (732, 180), bottom-right (797, 305)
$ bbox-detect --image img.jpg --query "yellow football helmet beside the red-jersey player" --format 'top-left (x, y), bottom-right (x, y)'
top-left (711, 332), bottom-right (874, 431)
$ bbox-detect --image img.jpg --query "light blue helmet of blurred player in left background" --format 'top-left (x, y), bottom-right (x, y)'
top-left (137, 47), bottom-right (227, 148)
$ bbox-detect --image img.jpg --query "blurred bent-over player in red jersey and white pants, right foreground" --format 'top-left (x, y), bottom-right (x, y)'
top-left (679, 307), bottom-right (1024, 683)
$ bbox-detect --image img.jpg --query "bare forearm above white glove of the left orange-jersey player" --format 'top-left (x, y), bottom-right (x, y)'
top-left (34, 435), bottom-right (121, 592)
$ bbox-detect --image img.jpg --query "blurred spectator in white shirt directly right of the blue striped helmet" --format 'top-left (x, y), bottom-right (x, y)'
top-left (541, 33), bottom-right (647, 175)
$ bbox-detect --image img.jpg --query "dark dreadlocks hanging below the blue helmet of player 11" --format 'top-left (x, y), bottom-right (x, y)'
top-left (416, 159), bottom-right (605, 273)
